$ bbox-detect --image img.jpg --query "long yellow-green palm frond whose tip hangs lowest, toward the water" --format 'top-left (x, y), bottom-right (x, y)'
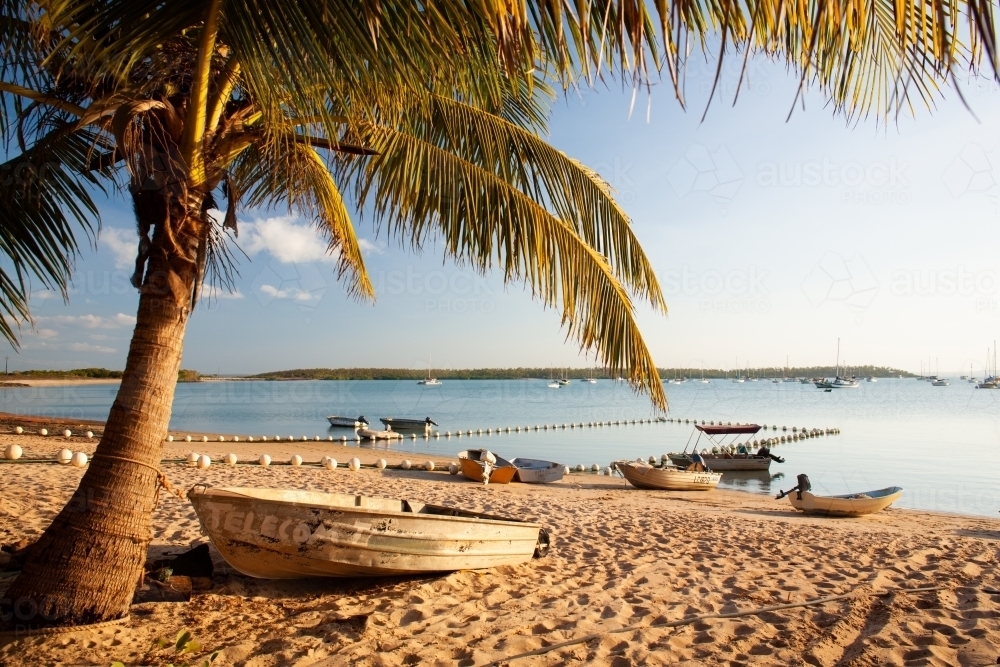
top-left (357, 126), bottom-right (666, 409)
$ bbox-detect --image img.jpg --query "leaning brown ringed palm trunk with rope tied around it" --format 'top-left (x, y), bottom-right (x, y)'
top-left (0, 197), bottom-right (203, 628)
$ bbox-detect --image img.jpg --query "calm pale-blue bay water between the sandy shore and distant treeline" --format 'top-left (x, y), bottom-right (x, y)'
top-left (0, 379), bottom-right (1000, 517)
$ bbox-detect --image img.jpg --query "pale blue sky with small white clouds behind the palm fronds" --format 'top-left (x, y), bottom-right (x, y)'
top-left (17, 59), bottom-right (1000, 374)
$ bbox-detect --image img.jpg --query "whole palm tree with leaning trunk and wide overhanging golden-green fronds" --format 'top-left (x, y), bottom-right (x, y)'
top-left (0, 0), bottom-right (994, 625)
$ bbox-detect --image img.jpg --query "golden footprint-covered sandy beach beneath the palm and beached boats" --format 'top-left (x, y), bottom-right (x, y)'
top-left (0, 435), bottom-right (1000, 667)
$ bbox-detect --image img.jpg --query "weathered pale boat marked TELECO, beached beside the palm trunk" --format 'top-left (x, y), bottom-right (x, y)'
top-left (189, 487), bottom-right (548, 579)
